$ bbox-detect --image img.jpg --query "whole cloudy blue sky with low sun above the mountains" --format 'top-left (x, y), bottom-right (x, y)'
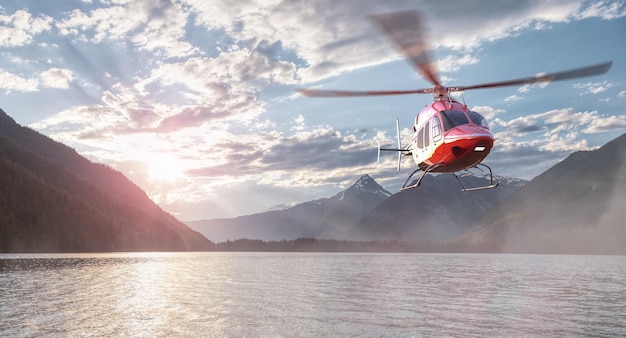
top-left (0, 0), bottom-right (626, 220)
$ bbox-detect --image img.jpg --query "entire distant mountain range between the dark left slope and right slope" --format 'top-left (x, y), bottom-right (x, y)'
top-left (188, 175), bottom-right (525, 243)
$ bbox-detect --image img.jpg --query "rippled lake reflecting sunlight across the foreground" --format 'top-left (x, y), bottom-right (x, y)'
top-left (0, 252), bottom-right (626, 337)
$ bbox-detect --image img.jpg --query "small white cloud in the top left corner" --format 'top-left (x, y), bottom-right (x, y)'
top-left (0, 9), bottom-right (53, 47)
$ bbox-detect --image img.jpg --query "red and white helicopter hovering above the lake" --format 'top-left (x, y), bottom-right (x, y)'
top-left (297, 10), bottom-right (613, 191)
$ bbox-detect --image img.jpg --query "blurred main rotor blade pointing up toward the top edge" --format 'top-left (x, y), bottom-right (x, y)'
top-left (370, 11), bottom-right (441, 86)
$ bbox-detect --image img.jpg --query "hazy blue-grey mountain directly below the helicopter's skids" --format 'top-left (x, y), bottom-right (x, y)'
top-left (357, 174), bottom-right (526, 242)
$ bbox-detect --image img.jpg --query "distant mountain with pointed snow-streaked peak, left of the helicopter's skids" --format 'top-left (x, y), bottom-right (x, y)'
top-left (188, 175), bottom-right (391, 242)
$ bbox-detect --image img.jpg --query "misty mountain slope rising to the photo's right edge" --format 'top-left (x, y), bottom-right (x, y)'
top-left (460, 134), bottom-right (626, 254)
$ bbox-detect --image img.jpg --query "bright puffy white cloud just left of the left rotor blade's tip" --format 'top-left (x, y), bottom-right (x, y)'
top-left (129, 49), bottom-right (295, 126)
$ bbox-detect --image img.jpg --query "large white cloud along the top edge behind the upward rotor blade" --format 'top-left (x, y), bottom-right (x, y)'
top-left (187, 0), bottom-right (580, 83)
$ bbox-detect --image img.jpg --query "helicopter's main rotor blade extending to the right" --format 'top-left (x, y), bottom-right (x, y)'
top-left (455, 61), bottom-right (613, 91)
